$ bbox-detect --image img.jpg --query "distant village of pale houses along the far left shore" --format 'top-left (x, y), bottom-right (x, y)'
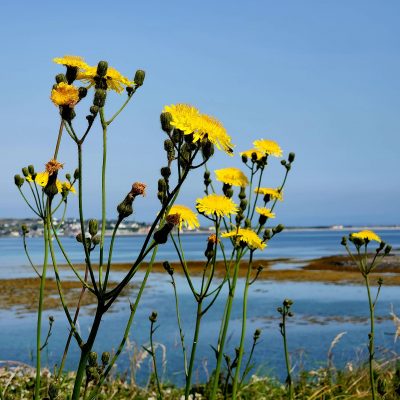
top-left (0, 218), bottom-right (209, 237)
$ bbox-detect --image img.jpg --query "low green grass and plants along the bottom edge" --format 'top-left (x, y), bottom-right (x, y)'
top-left (0, 360), bottom-right (400, 400)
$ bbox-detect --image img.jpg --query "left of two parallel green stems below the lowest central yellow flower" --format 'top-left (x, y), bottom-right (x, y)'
top-left (210, 250), bottom-right (241, 400)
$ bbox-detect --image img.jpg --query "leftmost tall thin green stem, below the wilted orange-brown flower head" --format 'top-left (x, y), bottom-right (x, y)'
top-left (34, 211), bottom-right (49, 400)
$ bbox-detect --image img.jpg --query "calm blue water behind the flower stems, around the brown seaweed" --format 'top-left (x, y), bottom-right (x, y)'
top-left (0, 230), bottom-right (400, 383)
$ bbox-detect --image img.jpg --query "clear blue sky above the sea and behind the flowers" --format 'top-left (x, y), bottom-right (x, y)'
top-left (0, 0), bottom-right (400, 225)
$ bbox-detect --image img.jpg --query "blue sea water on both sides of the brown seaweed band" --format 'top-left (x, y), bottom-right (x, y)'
top-left (0, 229), bottom-right (400, 385)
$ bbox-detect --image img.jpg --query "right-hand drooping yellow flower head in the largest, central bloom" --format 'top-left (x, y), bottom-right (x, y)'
top-left (193, 114), bottom-right (234, 156)
